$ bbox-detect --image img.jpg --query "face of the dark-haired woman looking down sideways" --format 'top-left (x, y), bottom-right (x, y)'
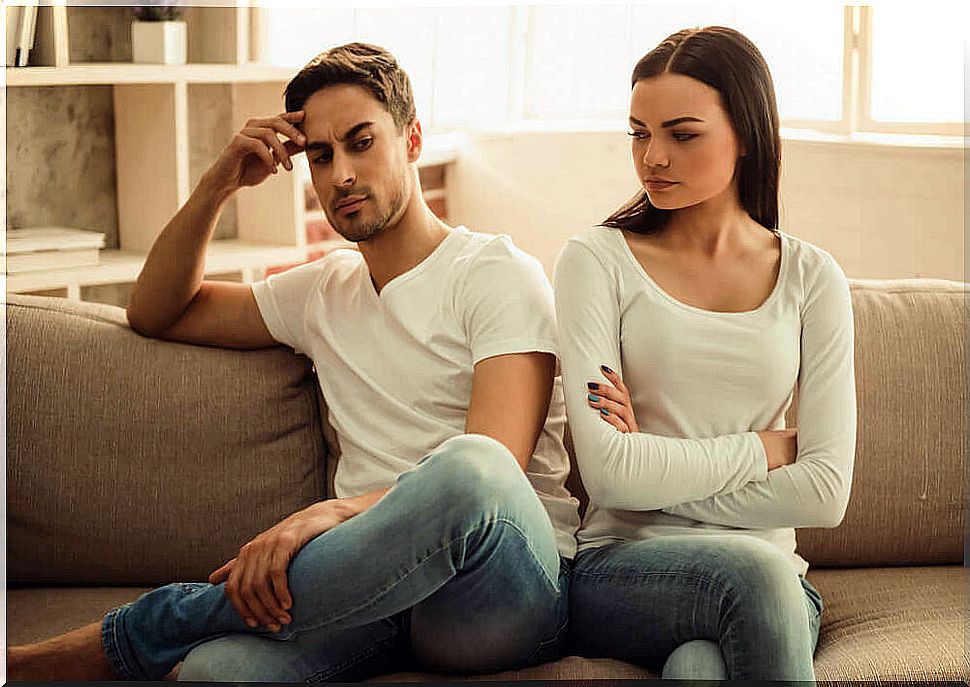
top-left (630, 74), bottom-right (743, 210)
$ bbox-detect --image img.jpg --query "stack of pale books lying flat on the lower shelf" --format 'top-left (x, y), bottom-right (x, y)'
top-left (4, 227), bottom-right (104, 274)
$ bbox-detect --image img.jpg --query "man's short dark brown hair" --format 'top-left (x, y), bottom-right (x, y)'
top-left (284, 43), bottom-right (415, 129)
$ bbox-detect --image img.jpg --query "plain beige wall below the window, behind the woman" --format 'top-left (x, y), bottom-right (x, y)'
top-left (448, 131), bottom-right (966, 281)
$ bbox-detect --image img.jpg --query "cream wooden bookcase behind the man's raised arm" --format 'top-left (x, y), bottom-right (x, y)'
top-left (5, 4), bottom-right (454, 305)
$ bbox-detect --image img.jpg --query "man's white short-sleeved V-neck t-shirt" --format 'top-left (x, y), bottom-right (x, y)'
top-left (252, 227), bottom-right (579, 558)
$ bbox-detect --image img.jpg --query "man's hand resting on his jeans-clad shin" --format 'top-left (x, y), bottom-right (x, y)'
top-left (209, 499), bottom-right (349, 632)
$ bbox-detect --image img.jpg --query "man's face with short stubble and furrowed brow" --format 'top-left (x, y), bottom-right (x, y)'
top-left (303, 84), bottom-right (412, 242)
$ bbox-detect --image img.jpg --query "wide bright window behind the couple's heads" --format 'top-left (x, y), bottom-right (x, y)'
top-left (257, 2), bottom-right (970, 134)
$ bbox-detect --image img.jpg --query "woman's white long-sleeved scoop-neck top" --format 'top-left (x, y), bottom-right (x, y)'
top-left (554, 227), bottom-right (856, 574)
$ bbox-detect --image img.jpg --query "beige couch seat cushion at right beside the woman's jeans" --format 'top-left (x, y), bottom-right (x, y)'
top-left (808, 566), bottom-right (970, 683)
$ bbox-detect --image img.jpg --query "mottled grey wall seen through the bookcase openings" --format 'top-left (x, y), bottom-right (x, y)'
top-left (5, 7), bottom-right (236, 248)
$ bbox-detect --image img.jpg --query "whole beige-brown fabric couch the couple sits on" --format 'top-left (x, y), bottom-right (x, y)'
top-left (7, 281), bottom-right (970, 680)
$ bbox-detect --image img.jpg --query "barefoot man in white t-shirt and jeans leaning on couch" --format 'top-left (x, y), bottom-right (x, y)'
top-left (8, 43), bottom-right (578, 681)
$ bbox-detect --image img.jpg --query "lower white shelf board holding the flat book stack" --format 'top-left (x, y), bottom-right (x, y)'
top-left (6, 239), bottom-right (353, 293)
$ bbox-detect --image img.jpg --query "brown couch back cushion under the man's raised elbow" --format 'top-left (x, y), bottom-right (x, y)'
top-left (7, 296), bottom-right (325, 586)
